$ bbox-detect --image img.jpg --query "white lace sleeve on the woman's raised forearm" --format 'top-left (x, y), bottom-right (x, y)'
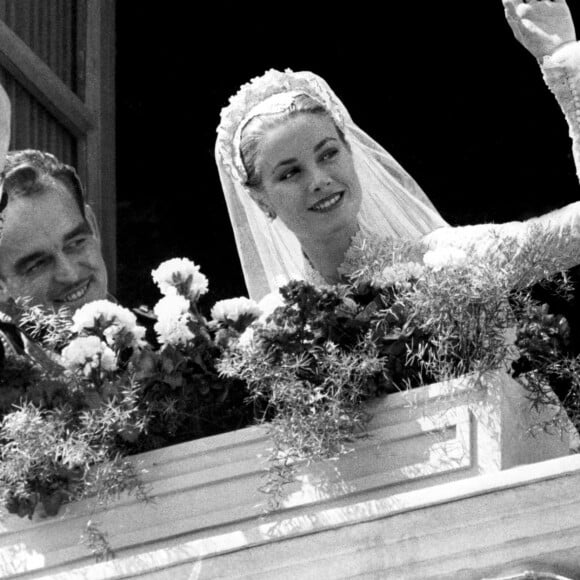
top-left (542, 42), bottom-right (580, 180)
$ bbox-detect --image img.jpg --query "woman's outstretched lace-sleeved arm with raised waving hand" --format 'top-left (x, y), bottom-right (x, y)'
top-left (423, 0), bottom-right (580, 270)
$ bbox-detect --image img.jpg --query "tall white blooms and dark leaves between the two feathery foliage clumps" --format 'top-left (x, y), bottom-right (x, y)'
top-left (139, 258), bottom-right (261, 450)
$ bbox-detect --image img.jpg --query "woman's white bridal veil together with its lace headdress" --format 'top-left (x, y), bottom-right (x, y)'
top-left (215, 69), bottom-right (447, 299)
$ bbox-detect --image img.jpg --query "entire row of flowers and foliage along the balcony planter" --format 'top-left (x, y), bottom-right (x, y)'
top-left (0, 227), bottom-right (580, 544)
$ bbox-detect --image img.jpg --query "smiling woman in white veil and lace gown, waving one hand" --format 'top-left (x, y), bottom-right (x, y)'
top-left (216, 0), bottom-right (580, 299)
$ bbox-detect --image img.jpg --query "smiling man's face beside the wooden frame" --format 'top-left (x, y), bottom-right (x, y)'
top-left (0, 180), bottom-right (107, 313)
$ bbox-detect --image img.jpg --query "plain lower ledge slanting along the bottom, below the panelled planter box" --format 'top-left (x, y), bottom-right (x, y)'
top-left (30, 456), bottom-right (580, 580)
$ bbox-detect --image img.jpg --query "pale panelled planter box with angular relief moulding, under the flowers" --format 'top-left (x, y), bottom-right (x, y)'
top-left (0, 374), bottom-right (568, 578)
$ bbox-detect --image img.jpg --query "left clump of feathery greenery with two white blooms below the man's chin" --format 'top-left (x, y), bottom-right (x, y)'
top-left (0, 301), bottom-right (146, 517)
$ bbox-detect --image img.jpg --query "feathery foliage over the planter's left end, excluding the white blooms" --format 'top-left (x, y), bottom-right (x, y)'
top-left (0, 300), bottom-right (150, 517)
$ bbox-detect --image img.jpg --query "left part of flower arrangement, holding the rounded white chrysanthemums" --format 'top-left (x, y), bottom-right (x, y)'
top-left (0, 259), bottom-right (260, 517)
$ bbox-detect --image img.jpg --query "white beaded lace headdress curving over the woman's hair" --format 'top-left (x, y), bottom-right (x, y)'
top-left (216, 69), bottom-right (348, 184)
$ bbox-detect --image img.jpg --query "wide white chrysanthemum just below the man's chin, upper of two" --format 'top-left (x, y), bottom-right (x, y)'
top-left (71, 300), bottom-right (145, 348)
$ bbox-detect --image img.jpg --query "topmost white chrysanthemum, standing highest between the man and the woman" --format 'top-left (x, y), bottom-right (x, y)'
top-left (151, 258), bottom-right (208, 300)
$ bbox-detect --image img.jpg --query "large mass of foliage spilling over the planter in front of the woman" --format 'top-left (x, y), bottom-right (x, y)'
top-left (219, 231), bottom-right (571, 507)
